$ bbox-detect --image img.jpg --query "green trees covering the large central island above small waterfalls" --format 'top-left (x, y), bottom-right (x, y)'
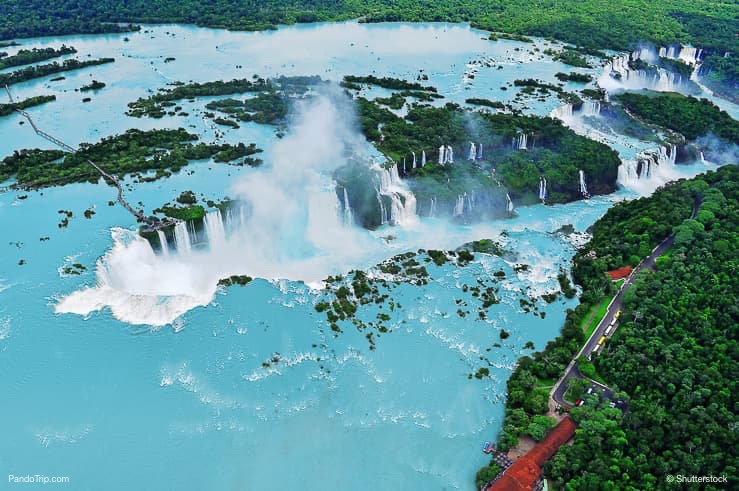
top-left (352, 98), bottom-right (620, 212)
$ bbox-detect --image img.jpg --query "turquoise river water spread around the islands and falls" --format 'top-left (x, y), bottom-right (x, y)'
top-left (0, 22), bottom-right (732, 490)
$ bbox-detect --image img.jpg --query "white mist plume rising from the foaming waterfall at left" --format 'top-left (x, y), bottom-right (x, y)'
top-left (56, 91), bottom-right (404, 326)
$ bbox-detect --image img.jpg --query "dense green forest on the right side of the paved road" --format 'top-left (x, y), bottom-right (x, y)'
top-left (546, 166), bottom-right (739, 490)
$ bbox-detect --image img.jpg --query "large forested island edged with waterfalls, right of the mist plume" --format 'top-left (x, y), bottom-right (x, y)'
top-left (335, 97), bottom-right (620, 228)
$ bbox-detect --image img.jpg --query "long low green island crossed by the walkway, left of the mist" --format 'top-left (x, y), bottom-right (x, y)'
top-left (0, 129), bottom-right (258, 188)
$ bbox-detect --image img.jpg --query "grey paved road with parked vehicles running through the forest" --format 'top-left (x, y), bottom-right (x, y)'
top-left (550, 197), bottom-right (702, 407)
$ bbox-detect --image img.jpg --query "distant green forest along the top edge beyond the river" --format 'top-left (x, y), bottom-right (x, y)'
top-left (0, 0), bottom-right (739, 95)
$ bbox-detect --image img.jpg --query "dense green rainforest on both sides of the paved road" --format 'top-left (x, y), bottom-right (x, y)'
top-left (482, 165), bottom-right (739, 491)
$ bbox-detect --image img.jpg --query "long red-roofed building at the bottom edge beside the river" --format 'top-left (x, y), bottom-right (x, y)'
top-left (487, 416), bottom-right (577, 491)
